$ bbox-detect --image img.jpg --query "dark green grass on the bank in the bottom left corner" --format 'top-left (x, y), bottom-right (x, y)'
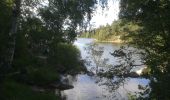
top-left (0, 80), bottom-right (59, 100)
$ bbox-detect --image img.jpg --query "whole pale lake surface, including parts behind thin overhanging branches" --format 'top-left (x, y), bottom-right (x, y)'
top-left (62, 39), bottom-right (149, 100)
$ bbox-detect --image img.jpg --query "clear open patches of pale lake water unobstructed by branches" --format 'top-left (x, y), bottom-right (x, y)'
top-left (62, 38), bottom-right (149, 100)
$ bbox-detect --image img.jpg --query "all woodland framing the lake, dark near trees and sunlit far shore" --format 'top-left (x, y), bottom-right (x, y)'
top-left (0, 0), bottom-right (170, 100)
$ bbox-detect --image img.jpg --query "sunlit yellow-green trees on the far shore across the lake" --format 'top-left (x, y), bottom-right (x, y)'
top-left (80, 20), bottom-right (140, 41)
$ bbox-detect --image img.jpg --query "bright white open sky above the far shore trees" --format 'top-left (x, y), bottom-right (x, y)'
top-left (90, 0), bottom-right (119, 28)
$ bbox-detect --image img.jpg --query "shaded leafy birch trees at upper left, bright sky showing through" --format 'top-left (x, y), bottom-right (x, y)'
top-left (0, 0), bottom-right (96, 76)
